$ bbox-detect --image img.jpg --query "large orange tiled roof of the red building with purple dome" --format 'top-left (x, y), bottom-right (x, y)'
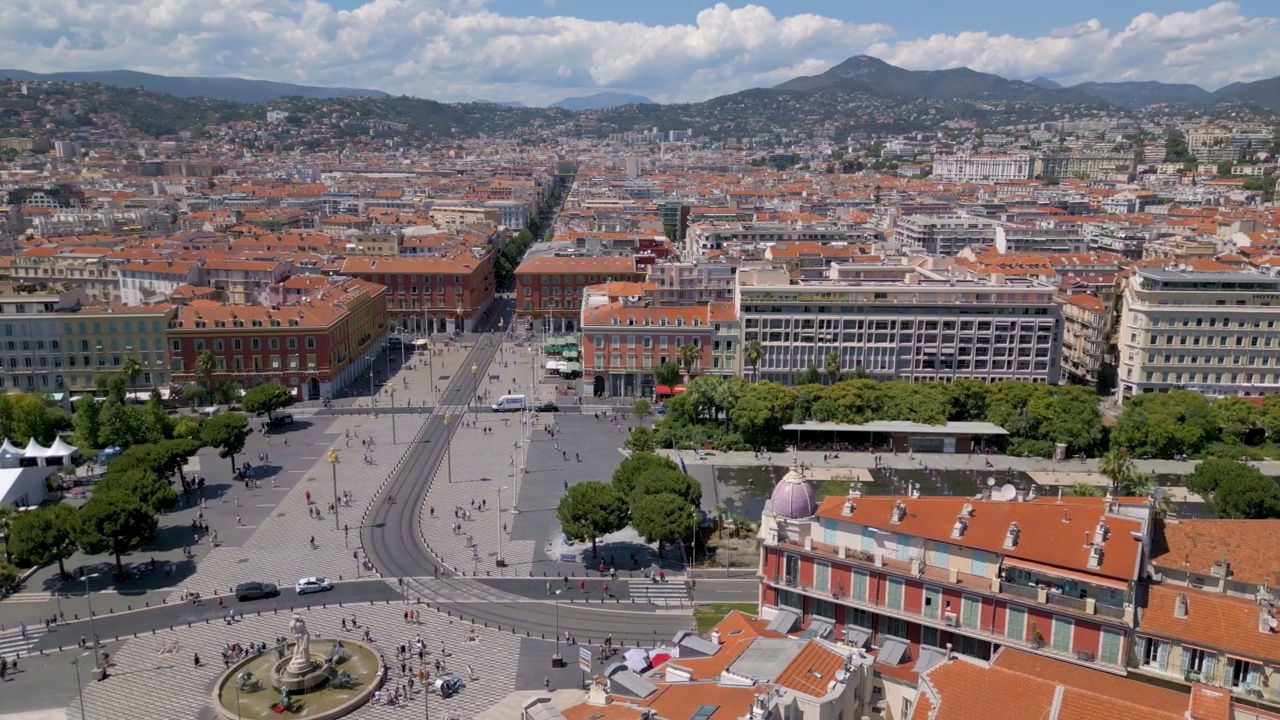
top-left (817, 496), bottom-right (1142, 580)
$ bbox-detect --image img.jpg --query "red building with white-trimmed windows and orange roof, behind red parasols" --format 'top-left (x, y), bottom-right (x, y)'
top-left (580, 283), bottom-right (711, 397)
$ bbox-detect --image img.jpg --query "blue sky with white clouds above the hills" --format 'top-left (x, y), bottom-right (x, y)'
top-left (0, 0), bottom-right (1280, 105)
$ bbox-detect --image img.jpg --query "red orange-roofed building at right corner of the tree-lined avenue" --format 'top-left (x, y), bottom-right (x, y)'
top-left (516, 255), bottom-right (645, 332)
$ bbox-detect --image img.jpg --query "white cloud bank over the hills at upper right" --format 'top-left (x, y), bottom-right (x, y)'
top-left (868, 1), bottom-right (1280, 90)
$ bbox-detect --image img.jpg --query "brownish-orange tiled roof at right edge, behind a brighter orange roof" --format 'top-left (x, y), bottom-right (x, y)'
top-left (1151, 520), bottom-right (1280, 585)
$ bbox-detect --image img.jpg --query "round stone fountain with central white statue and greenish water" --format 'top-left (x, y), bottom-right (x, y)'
top-left (212, 614), bottom-right (383, 720)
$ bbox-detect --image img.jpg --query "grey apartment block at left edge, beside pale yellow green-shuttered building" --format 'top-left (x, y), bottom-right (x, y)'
top-left (0, 283), bottom-right (87, 393)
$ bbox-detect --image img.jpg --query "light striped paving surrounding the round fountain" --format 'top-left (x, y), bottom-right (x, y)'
top-left (67, 596), bottom-right (520, 720)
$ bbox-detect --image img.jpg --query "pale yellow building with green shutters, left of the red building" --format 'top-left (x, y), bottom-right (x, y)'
top-left (55, 304), bottom-right (178, 395)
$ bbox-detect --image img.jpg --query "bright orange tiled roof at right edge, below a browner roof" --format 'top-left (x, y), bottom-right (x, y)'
top-left (1138, 584), bottom-right (1280, 664)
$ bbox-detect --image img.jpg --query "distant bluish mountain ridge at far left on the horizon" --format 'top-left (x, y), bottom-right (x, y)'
top-left (0, 70), bottom-right (389, 102)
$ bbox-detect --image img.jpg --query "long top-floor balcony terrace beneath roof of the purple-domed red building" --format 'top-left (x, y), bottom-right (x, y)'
top-left (774, 538), bottom-right (1132, 628)
